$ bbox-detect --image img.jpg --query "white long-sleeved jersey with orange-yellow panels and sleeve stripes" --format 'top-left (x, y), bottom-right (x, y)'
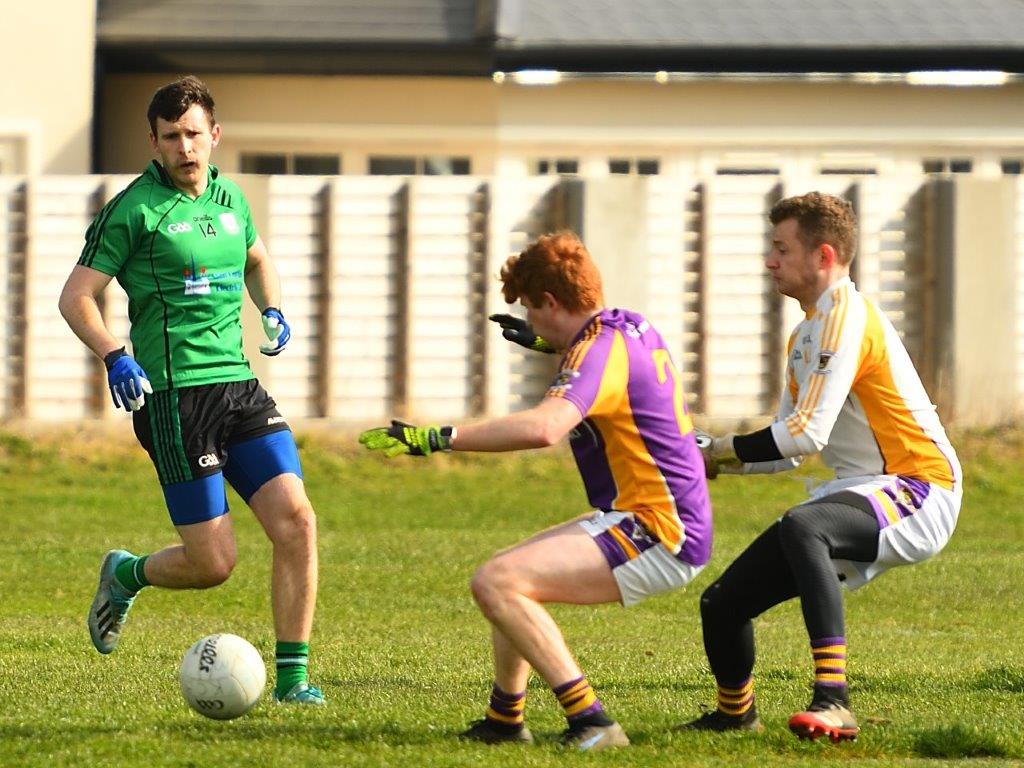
top-left (743, 278), bottom-right (962, 490)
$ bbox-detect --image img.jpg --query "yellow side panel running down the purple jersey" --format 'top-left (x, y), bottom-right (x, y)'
top-left (589, 331), bottom-right (683, 553)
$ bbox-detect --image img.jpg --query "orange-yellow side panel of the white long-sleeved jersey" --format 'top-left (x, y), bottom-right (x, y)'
top-left (853, 301), bottom-right (955, 489)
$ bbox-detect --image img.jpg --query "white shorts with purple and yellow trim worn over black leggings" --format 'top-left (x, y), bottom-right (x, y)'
top-left (811, 475), bottom-right (963, 590)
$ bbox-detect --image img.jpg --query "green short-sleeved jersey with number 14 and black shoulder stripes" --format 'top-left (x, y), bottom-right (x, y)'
top-left (78, 161), bottom-right (256, 391)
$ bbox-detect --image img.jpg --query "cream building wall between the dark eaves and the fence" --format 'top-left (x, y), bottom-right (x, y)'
top-left (100, 73), bottom-right (1024, 176)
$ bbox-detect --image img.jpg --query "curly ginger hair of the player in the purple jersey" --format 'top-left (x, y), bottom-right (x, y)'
top-left (501, 231), bottom-right (604, 312)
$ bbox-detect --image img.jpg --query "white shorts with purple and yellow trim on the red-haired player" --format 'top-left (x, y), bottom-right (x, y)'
top-left (580, 510), bottom-right (703, 608)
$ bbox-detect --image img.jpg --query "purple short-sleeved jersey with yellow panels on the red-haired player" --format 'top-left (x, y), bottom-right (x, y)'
top-left (547, 309), bottom-right (712, 565)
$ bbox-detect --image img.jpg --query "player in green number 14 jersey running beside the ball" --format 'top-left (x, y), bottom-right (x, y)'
top-left (60, 77), bottom-right (324, 705)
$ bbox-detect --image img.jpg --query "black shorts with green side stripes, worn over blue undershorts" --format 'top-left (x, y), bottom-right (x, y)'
top-left (132, 379), bottom-right (289, 485)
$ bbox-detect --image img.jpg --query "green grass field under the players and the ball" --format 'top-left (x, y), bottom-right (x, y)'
top-left (0, 433), bottom-right (1024, 766)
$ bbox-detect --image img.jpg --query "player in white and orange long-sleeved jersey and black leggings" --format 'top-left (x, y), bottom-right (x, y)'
top-left (688, 193), bottom-right (963, 740)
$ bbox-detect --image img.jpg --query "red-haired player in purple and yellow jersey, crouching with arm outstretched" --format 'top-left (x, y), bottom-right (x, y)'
top-left (359, 232), bottom-right (711, 751)
